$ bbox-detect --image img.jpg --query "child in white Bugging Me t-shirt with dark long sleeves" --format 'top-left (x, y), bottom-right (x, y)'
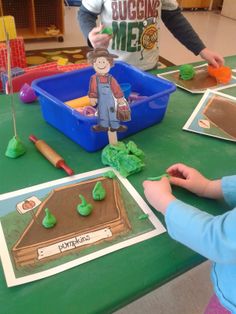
top-left (79, 0), bottom-right (224, 70)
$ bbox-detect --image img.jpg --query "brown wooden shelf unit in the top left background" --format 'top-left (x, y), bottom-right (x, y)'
top-left (0, 0), bottom-right (64, 39)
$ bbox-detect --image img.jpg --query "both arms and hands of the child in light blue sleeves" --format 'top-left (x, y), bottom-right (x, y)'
top-left (143, 169), bottom-right (236, 263)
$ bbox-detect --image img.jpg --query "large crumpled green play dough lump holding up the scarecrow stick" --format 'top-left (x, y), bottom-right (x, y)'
top-left (101, 141), bottom-right (144, 177)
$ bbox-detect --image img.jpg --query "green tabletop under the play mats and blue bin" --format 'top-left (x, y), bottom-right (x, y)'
top-left (0, 57), bottom-right (236, 314)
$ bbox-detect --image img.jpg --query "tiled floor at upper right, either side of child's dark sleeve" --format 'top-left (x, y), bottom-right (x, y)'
top-left (160, 11), bottom-right (236, 65)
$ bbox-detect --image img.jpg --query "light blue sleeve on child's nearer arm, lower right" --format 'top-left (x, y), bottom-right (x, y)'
top-left (165, 200), bottom-right (236, 263)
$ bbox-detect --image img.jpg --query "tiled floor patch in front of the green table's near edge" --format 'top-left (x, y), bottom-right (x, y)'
top-left (115, 262), bottom-right (213, 314)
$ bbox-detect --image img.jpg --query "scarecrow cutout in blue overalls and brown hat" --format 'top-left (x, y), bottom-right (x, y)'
top-left (87, 48), bottom-right (127, 132)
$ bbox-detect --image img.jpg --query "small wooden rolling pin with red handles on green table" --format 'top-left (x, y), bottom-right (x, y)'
top-left (29, 135), bottom-right (74, 176)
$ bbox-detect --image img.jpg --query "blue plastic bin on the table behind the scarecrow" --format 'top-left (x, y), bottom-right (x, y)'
top-left (32, 61), bottom-right (176, 152)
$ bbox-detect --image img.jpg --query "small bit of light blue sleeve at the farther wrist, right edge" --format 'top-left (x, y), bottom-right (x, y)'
top-left (221, 175), bottom-right (236, 207)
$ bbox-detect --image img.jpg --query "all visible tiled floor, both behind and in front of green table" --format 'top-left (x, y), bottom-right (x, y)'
top-left (26, 7), bottom-right (236, 314)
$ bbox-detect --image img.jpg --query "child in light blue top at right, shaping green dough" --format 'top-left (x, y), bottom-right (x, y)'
top-left (143, 164), bottom-right (236, 313)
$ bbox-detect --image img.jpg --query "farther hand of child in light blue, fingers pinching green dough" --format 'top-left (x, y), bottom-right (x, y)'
top-left (166, 164), bottom-right (222, 199)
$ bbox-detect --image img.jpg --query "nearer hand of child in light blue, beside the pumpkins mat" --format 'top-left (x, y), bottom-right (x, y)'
top-left (143, 178), bottom-right (175, 214)
